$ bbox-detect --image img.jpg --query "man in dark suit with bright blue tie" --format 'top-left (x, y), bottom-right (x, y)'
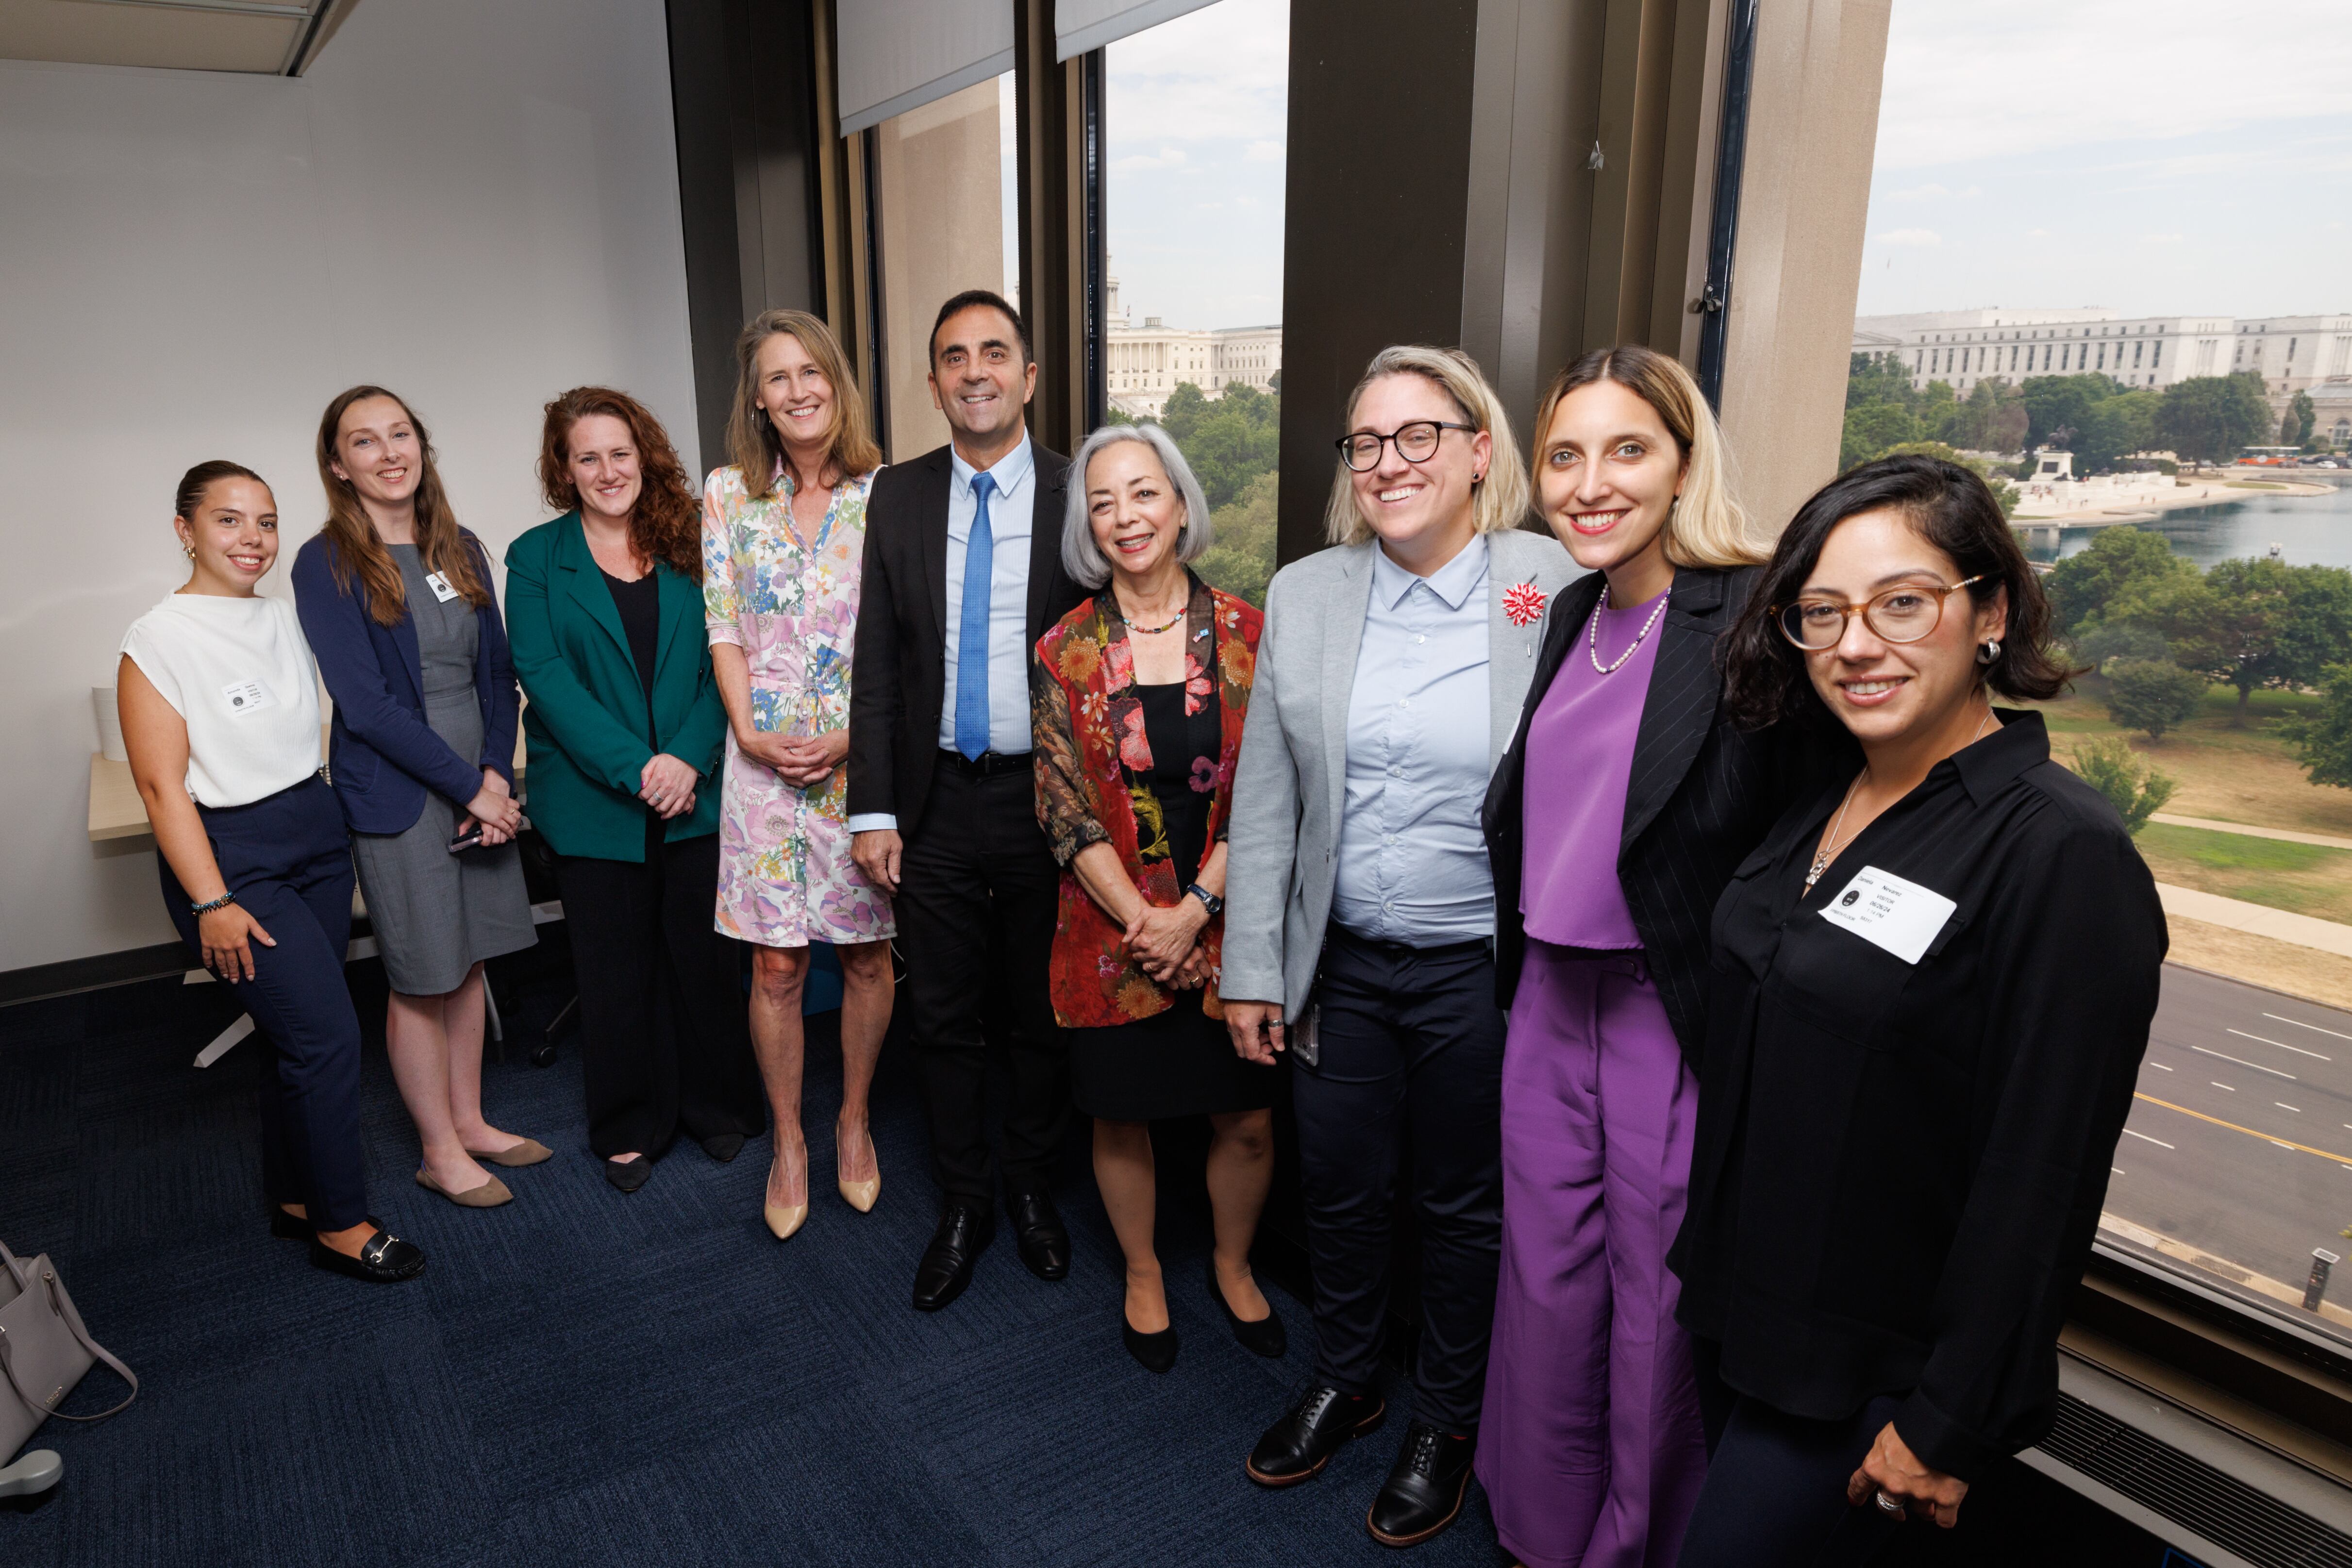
top-left (849, 289), bottom-right (1086, 1312)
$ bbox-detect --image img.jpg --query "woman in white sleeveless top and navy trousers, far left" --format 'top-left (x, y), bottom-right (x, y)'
top-left (115, 463), bottom-right (426, 1284)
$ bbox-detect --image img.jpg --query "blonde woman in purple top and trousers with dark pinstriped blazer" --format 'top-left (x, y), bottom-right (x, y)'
top-left (1477, 348), bottom-right (1825, 1568)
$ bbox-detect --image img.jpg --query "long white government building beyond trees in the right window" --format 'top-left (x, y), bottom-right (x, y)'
top-left (1853, 306), bottom-right (2352, 409)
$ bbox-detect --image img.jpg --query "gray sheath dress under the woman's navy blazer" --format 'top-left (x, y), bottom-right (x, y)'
top-left (350, 545), bottom-right (539, 997)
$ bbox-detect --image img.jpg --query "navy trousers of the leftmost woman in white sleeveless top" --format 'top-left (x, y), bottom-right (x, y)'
top-left (155, 778), bottom-right (367, 1230)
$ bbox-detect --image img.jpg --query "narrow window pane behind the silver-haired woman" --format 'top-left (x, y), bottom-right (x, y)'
top-left (1103, 0), bottom-right (1289, 602)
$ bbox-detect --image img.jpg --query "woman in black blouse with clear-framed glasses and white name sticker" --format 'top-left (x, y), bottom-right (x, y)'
top-left (1672, 458), bottom-right (2166, 1568)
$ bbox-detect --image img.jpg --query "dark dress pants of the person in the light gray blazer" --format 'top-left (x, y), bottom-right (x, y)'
top-left (1291, 926), bottom-right (1503, 1436)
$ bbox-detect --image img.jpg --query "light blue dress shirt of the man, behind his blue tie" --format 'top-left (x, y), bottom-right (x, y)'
top-left (849, 433), bottom-right (1037, 832)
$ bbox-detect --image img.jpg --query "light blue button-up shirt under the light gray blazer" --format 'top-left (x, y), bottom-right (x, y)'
top-left (1331, 534), bottom-right (1494, 948)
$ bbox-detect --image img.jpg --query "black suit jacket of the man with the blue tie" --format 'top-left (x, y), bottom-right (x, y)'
top-left (849, 440), bottom-right (1086, 834)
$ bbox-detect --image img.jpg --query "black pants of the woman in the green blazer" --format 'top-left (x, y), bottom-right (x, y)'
top-left (555, 827), bottom-right (767, 1159)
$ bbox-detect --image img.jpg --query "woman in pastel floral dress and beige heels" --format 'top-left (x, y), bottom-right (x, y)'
top-left (703, 310), bottom-right (899, 1241)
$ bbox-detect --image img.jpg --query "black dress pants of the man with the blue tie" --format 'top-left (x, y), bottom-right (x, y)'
top-left (896, 752), bottom-right (1070, 1206)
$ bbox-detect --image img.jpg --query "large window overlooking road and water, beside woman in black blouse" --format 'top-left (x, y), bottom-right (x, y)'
top-left (1842, 0), bottom-right (2352, 1345)
